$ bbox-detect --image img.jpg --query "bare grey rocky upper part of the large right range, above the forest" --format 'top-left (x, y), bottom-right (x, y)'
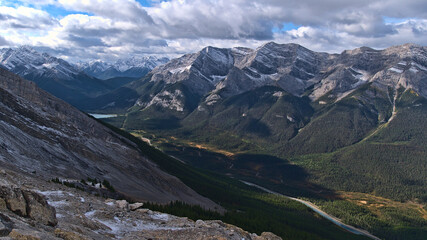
top-left (98, 42), bottom-right (427, 138)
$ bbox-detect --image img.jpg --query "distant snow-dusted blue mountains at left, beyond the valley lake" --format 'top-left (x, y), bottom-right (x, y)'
top-left (0, 46), bottom-right (167, 106)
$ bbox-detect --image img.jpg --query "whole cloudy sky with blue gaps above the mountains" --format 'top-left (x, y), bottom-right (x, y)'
top-left (0, 0), bottom-right (427, 62)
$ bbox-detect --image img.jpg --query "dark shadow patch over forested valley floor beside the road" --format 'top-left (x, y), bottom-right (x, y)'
top-left (161, 143), bottom-right (339, 199)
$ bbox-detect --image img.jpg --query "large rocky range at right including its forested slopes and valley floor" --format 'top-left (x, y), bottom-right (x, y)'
top-left (97, 42), bottom-right (427, 221)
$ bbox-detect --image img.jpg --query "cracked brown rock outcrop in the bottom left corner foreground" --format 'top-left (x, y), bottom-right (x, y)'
top-left (0, 186), bottom-right (58, 226)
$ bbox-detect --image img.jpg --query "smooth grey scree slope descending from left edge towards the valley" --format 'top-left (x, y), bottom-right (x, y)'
top-left (0, 68), bottom-right (219, 209)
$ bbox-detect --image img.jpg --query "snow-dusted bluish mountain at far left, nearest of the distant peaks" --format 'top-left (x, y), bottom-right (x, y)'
top-left (0, 46), bottom-right (112, 104)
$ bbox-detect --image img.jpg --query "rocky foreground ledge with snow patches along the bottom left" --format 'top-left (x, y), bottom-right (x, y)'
top-left (0, 169), bottom-right (280, 240)
